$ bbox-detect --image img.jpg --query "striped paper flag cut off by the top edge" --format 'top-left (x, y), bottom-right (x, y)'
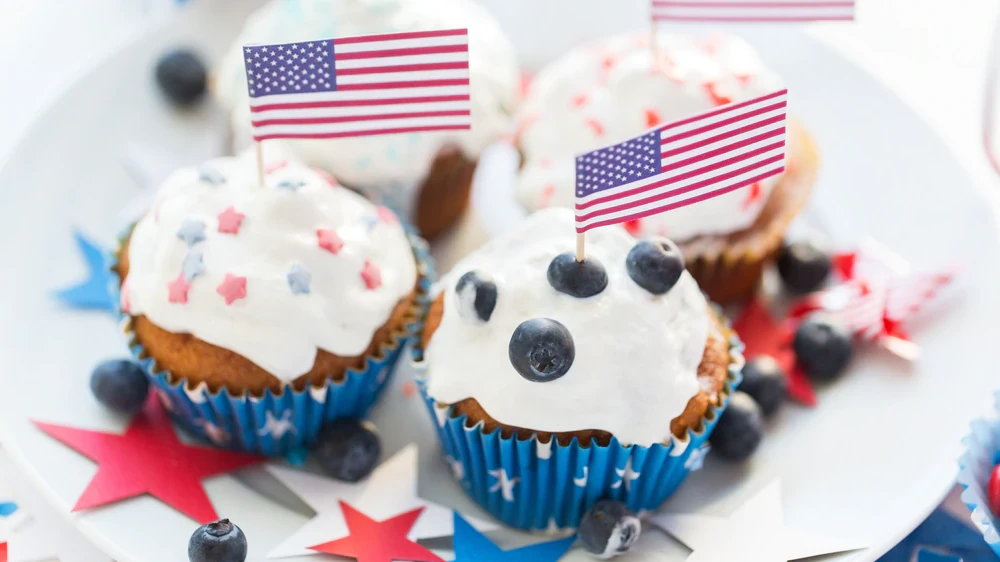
top-left (651, 0), bottom-right (854, 23)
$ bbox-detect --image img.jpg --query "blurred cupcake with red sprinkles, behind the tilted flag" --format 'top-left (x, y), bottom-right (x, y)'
top-left (516, 33), bottom-right (818, 303)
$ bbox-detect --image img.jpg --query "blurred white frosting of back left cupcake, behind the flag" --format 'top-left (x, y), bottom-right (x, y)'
top-left (215, 0), bottom-right (520, 188)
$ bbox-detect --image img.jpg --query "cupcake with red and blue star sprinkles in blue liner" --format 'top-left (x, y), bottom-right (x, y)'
top-left (113, 153), bottom-right (428, 455)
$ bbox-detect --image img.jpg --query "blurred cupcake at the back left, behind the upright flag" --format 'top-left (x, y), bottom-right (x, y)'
top-left (213, 0), bottom-right (520, 238)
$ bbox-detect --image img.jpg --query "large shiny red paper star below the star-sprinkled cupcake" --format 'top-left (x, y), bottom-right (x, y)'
top-left (34, 392), bottom-right (264, 523)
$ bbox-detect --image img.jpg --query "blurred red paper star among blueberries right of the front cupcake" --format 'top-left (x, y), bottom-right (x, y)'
top-left (733, 300), bottom-right (816, 406)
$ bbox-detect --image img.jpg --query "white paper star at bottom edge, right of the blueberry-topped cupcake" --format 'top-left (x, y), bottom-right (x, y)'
top-left (649, 480), bottom-right (861, 562)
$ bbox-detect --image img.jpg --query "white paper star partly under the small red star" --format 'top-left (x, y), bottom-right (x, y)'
top-left (267, 444), bottom-right (496, 558)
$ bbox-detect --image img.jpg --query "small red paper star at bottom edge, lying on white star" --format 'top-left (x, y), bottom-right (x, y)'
top-left (309, 501), bottom-right (444, 562)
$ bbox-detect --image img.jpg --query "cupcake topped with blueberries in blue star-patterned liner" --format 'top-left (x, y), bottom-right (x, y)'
top-left (415, 209), bottom-right (743, 529)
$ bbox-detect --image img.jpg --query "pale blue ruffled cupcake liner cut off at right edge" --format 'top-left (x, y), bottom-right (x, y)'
top-left (958, 392), bottom-right (1000, 556)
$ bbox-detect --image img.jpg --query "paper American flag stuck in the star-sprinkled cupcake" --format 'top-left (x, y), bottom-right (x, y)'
top-left (243, 29), bottom-right (472, 141)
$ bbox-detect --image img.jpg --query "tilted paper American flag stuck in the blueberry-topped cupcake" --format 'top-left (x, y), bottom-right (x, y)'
top-left (576, 90), bottom-right (788, 233)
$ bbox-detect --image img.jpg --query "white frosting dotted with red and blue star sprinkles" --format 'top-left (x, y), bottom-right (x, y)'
top-left (123, 152), bottom-right (417, 381)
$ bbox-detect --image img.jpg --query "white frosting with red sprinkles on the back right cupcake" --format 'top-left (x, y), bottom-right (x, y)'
top-left (517, 33), bottom-right (782, 241)
